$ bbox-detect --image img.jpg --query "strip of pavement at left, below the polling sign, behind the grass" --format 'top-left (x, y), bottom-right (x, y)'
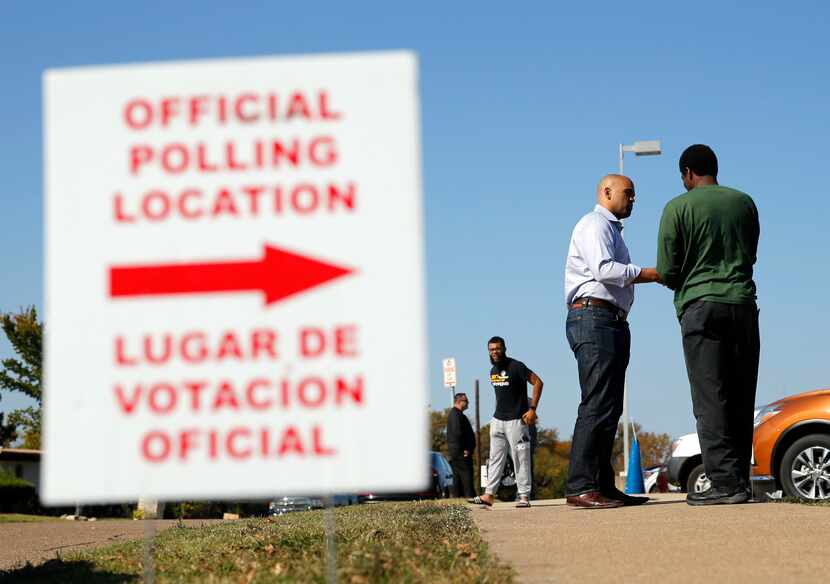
top-left (0, 519), bottom-right (220, 570)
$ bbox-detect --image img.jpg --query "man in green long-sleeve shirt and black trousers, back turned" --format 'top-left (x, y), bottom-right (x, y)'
top-left (657, 144), bottom-right (760, 505)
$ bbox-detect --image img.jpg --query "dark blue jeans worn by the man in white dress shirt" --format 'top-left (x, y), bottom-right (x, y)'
top-left (565, 306), bottom-right (631, 496)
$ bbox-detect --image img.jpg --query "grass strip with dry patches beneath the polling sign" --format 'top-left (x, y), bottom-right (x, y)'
top-left (0, 503), bottom-right (514, 584)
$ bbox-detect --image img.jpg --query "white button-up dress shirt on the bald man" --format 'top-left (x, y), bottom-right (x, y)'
top-left (565, 205), bottom-right (642, 312)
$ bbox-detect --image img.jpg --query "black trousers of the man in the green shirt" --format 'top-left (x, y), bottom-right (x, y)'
top-left (680, 301), bottom-right (761, 489)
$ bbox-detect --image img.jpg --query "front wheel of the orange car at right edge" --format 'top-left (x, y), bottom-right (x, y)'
top-left (778, 434), bottom-right (830, 500)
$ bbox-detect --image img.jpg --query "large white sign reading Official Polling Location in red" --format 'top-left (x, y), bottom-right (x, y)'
top-left (42, 52), bottom-right (429, 504)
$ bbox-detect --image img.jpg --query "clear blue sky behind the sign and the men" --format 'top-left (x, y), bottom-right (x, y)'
top-left (0, 1), bottom-right (830, 437)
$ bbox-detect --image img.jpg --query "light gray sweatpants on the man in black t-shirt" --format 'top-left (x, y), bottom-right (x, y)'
top-left (484, 418), bottom-right (531, 496)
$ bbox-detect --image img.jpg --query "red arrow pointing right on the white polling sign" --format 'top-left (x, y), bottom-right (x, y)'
top-left (110, 244), bottom-right (354, 304)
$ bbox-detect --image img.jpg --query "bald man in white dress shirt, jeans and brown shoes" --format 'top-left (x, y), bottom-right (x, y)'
top-left (565, 174), bottom-right (660, 509)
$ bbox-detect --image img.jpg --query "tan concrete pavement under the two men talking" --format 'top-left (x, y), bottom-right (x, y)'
top-left (473, 493), bottom-right (830, 584)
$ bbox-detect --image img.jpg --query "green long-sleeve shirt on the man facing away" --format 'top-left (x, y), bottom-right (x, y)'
top-left (657, 185), bottom-right (760, 318)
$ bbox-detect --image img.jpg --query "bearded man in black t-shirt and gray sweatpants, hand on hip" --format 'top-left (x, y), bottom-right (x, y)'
top-left (472, 337), bottom-right (543, 507)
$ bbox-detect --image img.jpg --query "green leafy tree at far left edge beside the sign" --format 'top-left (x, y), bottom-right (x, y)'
top-left (0, 306), bottom-right (43, 448)
